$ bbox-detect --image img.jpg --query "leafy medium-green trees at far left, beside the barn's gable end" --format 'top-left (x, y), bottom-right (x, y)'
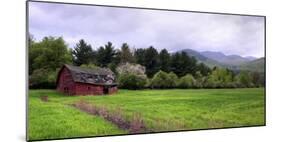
top-left (28, 37), bottom-right (71, 88)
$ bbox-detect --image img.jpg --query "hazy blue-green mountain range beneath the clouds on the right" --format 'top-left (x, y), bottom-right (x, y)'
top-left (180, 49), bottom-right (264, 72)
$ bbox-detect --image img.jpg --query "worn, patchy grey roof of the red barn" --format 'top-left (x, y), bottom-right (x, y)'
top-left (64, 65), bottom-right (117, 85)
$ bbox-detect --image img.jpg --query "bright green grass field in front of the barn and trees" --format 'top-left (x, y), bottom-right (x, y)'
top-left (28, 88), bottom-right (265, 140)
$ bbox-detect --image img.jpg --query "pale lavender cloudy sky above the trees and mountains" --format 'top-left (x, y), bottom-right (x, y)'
top-left (29, 2), bottom-right (264, 57)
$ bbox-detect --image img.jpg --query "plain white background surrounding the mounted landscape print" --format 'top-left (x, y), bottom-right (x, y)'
top-left (0, 0), bottom-right (281, 142)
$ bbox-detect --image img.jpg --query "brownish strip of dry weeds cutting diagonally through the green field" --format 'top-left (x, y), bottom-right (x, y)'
top-left (72, 101), bottom-right (146, 133)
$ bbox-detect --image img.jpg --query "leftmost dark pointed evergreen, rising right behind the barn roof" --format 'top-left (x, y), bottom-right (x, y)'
top-left (72, 39), bottom-right (95, 66)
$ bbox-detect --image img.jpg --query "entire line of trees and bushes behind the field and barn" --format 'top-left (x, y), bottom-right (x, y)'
top-left (28, 36), bottom-right (264, 89)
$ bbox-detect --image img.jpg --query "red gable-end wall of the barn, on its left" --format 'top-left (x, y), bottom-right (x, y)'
top-left (57, 67), bottom-right (75, 95)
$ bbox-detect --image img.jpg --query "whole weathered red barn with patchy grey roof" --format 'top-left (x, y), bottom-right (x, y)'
top-left (57, 65), bottom-right (118, 95)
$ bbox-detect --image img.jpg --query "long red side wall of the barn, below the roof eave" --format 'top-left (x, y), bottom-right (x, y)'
top-left (75, 82), bottom-right (103, 95)
